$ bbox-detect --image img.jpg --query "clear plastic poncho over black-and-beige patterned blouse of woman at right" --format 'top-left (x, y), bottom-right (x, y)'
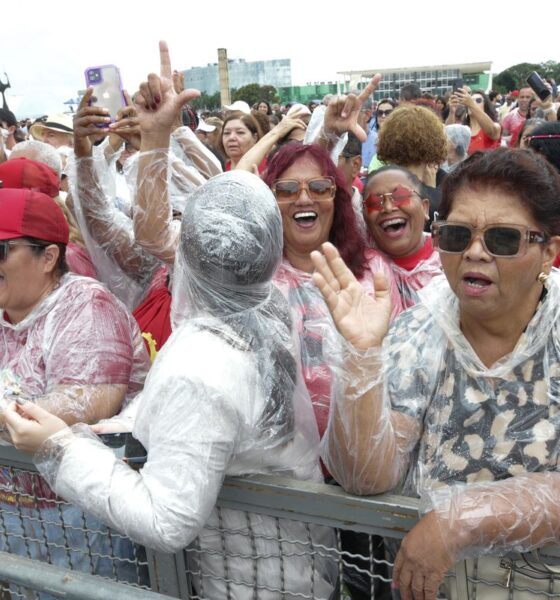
top-left (327, 271), bottom-right (560, 556)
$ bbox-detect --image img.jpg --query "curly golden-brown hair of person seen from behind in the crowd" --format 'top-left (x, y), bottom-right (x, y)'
top-left (377, 104), bottom-right (447, 167)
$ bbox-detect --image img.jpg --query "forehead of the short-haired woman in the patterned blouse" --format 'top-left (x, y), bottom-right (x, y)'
top-left (447, 187), bottom-right (540, 229)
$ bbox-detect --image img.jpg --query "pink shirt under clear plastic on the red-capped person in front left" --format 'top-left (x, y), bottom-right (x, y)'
top-left (0, 274), bottom-right (149, 397)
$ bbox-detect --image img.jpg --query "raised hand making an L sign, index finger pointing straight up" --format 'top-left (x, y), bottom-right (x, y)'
top-left (134, 42), bottom-right (200, 142)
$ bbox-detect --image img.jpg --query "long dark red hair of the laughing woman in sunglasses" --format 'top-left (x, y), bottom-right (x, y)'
top-left (263, 144), bottom-right (365, 278)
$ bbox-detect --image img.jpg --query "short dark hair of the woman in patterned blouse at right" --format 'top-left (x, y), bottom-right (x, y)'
top-left (439, 148), bottom-right (560, 235)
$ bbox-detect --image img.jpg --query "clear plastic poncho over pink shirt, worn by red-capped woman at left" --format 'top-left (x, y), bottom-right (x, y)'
top-left (0, 274), bottom-right (149, 423)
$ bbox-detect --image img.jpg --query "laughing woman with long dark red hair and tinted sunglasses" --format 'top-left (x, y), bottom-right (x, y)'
top-left (264, 144), bottom-right (402, 435)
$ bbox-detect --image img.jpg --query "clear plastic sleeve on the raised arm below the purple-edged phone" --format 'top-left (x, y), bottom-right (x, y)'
top-left (68, 152), bottom-right (159, 310)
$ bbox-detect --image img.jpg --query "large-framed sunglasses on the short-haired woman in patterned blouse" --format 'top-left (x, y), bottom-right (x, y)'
top-left (432, 221), bottom-right (548, 258)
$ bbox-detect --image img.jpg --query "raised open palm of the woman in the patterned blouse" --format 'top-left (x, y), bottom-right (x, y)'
top-left (311, 242), bottom-right (391, 351)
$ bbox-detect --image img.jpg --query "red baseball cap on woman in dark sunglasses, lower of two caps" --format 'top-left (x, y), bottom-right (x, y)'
top-left (0, 188), bottom-right (70, 244)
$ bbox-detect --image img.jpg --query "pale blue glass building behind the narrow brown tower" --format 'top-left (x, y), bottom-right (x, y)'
top-left (183, 58), bottom-right (292, 96)
